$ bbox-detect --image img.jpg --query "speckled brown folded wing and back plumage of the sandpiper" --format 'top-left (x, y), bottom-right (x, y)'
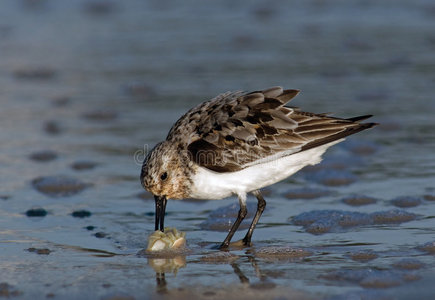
top-left (167, 87), bottom-right (375, 172)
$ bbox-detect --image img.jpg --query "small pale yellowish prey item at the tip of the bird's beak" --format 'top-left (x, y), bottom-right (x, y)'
top-left (147, 227), bottom-right (186, 252)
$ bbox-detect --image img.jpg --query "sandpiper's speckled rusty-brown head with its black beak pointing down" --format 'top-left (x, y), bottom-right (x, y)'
top-left (140, 141), bottom-right (190, 231)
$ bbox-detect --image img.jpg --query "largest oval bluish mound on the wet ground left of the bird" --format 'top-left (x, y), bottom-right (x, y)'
top-left (32, 175), bottom-right (89, 197)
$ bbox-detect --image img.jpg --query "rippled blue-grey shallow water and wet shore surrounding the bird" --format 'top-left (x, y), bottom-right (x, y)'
top-left (0, 0), bottom-right (435, 299)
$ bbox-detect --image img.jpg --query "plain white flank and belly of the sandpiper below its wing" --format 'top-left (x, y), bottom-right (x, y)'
top-left (190, 139), bottom-right (344, 199)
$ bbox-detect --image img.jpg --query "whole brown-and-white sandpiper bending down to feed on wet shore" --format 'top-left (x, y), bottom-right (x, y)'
top-left (140, 87), bottom-right (377, 249)
